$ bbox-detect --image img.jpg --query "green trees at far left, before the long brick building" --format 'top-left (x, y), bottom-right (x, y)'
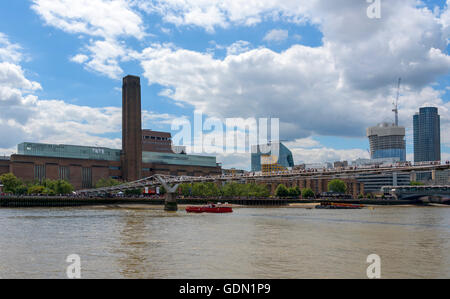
top-left (0, 173), bottom-right (74, 195)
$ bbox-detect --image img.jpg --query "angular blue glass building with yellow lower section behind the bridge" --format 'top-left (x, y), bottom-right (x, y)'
top-left (252, 142), bottom-right (294, 172)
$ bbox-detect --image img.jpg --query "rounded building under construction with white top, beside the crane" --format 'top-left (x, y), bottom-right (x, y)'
top-left (367, 123), bottom-right (406, 162)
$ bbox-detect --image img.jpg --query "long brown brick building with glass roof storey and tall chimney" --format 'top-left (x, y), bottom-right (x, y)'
top-left (0, 76), bottom-right (222, 190)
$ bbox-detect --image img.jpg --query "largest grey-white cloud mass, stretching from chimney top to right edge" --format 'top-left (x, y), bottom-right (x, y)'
top-left (137, 0), bottom-right (450, 147)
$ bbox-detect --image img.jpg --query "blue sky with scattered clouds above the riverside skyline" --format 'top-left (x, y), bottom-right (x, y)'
top-left (0, 0), bottom-right (450, 169)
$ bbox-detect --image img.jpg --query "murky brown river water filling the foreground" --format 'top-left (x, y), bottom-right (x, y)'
top-left (0, 206), bottom-right (450, 279)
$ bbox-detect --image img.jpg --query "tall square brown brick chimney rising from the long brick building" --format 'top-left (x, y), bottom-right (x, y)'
top-left (122, 76), bottom-right (142, 181)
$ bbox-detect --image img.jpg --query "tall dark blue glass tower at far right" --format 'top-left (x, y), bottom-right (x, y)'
top-left (413, 107), bottom-right (441, 162)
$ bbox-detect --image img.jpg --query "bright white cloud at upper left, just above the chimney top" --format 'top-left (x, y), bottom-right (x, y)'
top-left (32, 0), bottom-right (146, 79)
